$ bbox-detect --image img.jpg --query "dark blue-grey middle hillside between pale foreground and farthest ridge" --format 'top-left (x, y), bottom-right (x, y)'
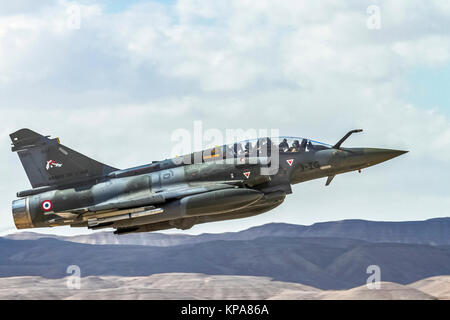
top-left (0, 236), bottom-right (450, 290)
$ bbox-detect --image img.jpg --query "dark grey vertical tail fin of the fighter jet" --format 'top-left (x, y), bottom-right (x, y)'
top-left (10, 129), bottom-right (118, 188)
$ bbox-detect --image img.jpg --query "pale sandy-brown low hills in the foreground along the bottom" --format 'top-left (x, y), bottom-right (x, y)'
top-left (0, 273), bottom-right (450, 300)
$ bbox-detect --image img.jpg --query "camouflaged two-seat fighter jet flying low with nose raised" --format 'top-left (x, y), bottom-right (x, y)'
top-left (10, 129), bottom-right (407, 235)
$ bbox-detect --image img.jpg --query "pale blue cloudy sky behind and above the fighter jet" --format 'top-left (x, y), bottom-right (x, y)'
top-left (0, 0), bottom-right (450, 234)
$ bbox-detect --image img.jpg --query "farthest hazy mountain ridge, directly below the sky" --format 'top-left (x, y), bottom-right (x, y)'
top-left (3, 217), bottom-right (450, 247)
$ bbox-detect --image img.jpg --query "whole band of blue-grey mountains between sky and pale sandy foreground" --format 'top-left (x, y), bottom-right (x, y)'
top-left (0, 218), bottom-right (450, 294)
